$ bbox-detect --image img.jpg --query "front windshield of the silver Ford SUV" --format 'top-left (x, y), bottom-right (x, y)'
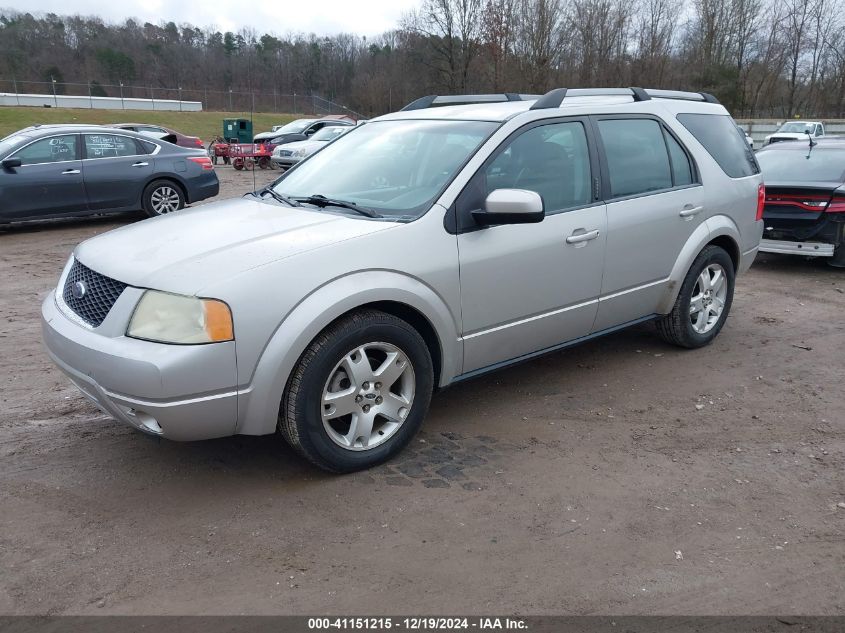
top-left (273, 120), bottom-right (498, 218)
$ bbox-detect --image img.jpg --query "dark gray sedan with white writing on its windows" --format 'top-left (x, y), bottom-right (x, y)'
top-left (0, 125), bottom-right (220, 223)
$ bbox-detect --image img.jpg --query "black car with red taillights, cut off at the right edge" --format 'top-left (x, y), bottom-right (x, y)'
top-left (756, 137), bottom-right (845, 267)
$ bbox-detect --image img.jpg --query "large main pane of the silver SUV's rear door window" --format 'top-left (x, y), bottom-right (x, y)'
top-left (598, 119), bottom-right (672, 198)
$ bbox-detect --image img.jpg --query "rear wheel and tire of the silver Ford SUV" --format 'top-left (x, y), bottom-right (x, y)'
top-left (656, 245), bottom-right (735, 349)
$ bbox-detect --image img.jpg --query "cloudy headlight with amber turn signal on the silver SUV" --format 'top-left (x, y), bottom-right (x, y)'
top-left (126, 290), bottom-right (235, 345)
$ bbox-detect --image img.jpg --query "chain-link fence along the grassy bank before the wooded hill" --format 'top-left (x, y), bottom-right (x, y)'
top-left (0, 79), bottom-right (365, 118)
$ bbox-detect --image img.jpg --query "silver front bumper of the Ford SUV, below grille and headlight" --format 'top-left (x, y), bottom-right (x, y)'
top-left (41, 288), bottom-right (238, 441)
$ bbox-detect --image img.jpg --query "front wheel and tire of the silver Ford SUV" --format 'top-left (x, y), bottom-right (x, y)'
top-left (278, 310), bottom-right (434, 473)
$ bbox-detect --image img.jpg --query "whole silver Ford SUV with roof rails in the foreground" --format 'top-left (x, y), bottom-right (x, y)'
top-left (42, 88), bottom-right (763, 472)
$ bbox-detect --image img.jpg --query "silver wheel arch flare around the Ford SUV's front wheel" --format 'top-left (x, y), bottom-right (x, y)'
top-left (236, 270), bottom-right (463, 435)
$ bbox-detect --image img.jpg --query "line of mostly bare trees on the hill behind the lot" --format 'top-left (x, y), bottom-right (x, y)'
top-left (0, 0), bottom-right (845, 118)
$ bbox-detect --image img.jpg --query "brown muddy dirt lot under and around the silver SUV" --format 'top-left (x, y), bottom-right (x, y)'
top-left (0, 169), bottom-right (845, 614)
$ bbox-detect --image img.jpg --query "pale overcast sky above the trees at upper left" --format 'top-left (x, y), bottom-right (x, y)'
top-left (0, 0), bottom-right (419, 36)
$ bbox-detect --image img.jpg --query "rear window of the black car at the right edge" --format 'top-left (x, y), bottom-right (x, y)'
top-left (757, 149), bottom-right (845, 183)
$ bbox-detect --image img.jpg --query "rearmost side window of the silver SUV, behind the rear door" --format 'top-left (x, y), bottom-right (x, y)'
top-left (678, 114), bottom-right (760, 178)
